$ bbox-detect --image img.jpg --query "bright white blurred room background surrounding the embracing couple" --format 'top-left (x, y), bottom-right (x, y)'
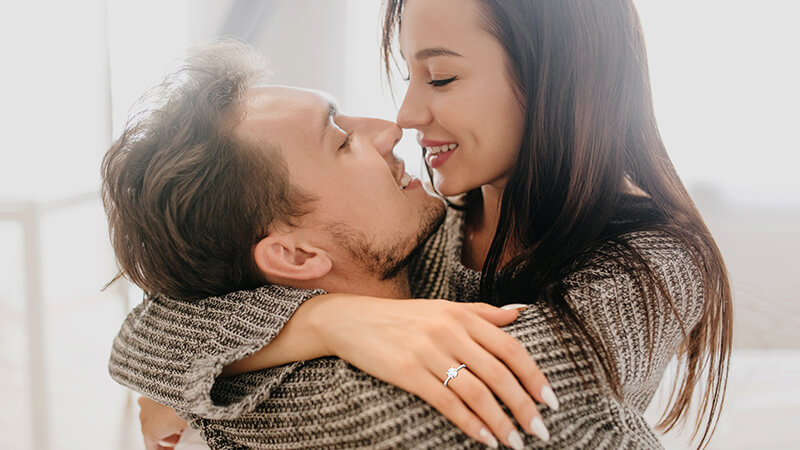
top-left (0, 0), bottom-right (800, 450)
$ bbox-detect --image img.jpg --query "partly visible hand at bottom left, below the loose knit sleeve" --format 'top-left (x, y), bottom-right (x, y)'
top-left (139, 397), bottom-right (186, 450)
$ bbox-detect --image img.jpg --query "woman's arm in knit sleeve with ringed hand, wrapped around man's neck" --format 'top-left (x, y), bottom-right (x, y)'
top-left (111, 292), bottom-right (557, 444)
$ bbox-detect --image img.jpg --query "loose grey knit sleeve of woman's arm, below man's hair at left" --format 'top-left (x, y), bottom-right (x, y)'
top-left (109, 286), bottom-right (325, 417)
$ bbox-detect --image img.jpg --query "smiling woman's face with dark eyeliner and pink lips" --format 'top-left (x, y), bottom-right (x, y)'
top-left (397, 0), bottom-right (524, 196)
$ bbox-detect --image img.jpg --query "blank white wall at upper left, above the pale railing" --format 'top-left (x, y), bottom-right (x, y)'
top-left (0, 0), bottom-right (108, 199)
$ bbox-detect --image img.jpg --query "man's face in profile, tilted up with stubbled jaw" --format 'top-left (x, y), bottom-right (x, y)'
top-left (236, 87), bottom-right (444, 278)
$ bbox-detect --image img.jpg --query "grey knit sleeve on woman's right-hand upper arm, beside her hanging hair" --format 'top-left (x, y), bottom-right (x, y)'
top-left (565, 231), bottom-right (704, 410)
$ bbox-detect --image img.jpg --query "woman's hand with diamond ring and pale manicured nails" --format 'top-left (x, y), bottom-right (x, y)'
top-left (303, 295), bottom-right (558, 448)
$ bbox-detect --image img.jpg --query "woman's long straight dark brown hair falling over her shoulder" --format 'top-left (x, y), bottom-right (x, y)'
top-left (382, 0), bottom-right (733, 447)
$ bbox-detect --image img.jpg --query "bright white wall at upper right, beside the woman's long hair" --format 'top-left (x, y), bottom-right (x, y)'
top-left (636, 0), bottom-right (800, 208)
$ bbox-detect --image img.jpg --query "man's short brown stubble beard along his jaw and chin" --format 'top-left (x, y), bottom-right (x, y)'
top-left (327, 203), bottom-right (446, 281)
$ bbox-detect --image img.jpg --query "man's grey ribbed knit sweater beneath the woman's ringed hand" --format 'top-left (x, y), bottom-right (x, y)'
top-left (190, 304), bottom-right (661, 449)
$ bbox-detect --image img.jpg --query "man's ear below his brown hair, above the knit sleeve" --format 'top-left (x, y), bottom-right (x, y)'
top-left (253, 232), bottom-right (333, 281)
